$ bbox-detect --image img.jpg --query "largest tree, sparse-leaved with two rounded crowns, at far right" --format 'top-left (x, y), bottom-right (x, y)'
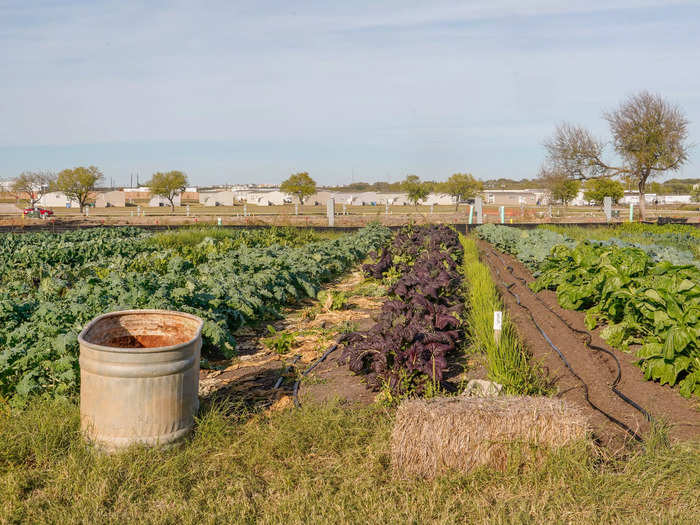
top-left (545, 91), bottom-right (690, 219)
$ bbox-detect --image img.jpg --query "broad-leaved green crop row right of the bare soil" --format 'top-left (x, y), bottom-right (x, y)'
top-left (478, 227), bottom-right (700, 397)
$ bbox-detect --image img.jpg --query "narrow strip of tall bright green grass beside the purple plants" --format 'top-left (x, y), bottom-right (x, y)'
top-left (461, 236), bottom-right (547, 394)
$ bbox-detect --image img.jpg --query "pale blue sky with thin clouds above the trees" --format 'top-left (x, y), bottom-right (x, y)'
top-left (0, 0), bottom-right (700, 184)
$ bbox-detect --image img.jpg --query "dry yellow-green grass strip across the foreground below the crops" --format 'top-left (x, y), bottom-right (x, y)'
top-left (0, 401), bottom-right (700, 523)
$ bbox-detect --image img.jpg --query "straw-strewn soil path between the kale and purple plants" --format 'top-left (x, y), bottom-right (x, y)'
top-left (200, 271), bottom-right (392, 410)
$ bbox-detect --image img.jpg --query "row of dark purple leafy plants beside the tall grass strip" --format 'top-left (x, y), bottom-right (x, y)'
top-left (341, 225), bottom-right (463, 397)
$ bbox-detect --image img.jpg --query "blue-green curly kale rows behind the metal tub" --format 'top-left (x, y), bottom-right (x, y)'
top-left (0, 226), bottom-right (390, 402)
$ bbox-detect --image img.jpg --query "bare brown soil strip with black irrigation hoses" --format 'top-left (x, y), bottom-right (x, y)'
top-left (479, 242), bottom-right (700, 445)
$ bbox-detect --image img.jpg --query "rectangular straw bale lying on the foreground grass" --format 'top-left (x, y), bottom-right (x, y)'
top-left (391, 397), bottom-right (588, 478)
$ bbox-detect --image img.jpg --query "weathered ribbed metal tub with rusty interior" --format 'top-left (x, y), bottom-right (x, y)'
top-left (78, 310), bottom-right (203, 451)
